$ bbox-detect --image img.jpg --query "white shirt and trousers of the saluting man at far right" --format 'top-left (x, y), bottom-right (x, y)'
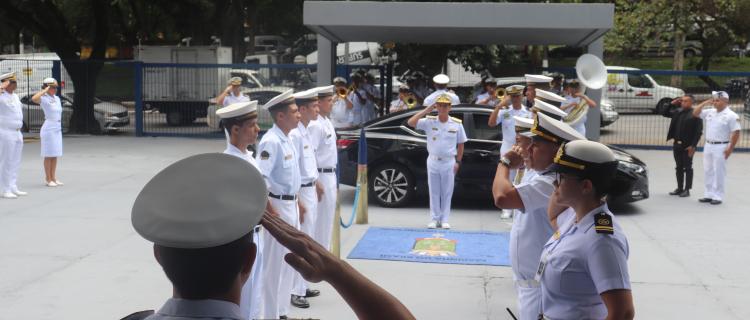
top-left (700, 107), bottom-right (741, 201)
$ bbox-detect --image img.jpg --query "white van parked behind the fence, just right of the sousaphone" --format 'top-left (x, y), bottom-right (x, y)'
top-left (603, 66), bottom-right (685, 113)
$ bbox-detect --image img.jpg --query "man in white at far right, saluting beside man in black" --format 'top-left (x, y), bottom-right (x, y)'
top-left (693, 91), bottom-right (741, 205)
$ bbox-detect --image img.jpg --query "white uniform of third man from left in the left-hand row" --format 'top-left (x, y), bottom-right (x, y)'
top-left (290, 121), bottom-right (318, 298)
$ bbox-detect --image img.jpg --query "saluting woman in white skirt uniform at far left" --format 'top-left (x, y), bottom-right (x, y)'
top-left (31, 78), bottom-right (64, 187)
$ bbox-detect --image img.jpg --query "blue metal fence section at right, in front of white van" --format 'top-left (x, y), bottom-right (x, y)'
top-left (555, 67), bottom-right (750, 151)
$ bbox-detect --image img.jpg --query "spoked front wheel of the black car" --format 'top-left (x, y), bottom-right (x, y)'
top-left (369, 164), bottom-right (416, 208)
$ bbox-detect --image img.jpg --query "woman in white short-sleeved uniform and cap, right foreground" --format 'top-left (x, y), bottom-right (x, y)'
top-left (536, 140), bottom-right (635, 319)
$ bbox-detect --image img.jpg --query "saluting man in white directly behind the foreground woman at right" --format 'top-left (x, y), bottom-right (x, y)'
top-left (492, 112), bottom-right (585, 320)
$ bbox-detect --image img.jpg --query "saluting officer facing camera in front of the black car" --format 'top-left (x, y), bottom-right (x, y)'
top-left (407, 93), bottom-right (467, 229)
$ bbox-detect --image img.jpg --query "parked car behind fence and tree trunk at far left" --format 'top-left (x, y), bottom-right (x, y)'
top-left (18, 92), bottom-right (130, 133)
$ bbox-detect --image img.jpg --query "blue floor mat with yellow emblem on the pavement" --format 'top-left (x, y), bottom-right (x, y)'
top-left (347, 227), bottom-right (510, 266)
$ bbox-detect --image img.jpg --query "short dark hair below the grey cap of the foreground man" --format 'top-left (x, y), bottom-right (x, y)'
top-left (154, 231), bottom-right (255, 299)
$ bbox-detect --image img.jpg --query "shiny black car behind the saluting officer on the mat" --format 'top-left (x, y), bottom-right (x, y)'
top-left (338, 104), bottom-right (648, 207)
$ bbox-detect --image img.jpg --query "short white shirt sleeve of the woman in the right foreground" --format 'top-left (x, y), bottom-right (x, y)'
top-left (587, 236), bottom-right (630, 294)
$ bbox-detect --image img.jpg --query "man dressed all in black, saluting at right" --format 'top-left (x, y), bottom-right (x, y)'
top-left (667, 95), bottom-right (703, 197)
